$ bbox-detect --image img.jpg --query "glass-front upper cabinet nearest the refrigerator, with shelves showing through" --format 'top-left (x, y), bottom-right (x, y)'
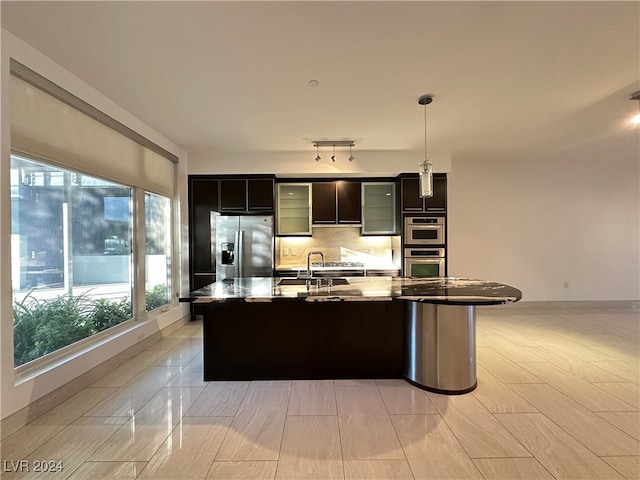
top-left (276, 183), bottom-right (311, 235)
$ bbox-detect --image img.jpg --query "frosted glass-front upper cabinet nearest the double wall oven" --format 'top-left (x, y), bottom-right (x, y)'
top-left (362, 182), bottom-right (397, 235)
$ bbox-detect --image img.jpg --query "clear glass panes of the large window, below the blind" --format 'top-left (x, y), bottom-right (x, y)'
top-left (11, 155), bottom-right (171, 366)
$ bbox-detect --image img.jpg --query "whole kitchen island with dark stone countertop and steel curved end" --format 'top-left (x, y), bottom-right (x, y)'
top-left (191, 277), bottom-right (522, 393)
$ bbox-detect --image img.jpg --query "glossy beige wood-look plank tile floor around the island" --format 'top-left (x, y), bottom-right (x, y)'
top-left (1, 304), bottom-right (640, 480)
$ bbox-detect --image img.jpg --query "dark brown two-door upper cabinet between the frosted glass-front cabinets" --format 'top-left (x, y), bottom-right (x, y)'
top-left (311, 180), bottom-right (362, 225)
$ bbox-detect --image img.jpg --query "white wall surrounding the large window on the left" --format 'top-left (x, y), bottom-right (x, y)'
top-left (0, 30), bottom-right (188, 418)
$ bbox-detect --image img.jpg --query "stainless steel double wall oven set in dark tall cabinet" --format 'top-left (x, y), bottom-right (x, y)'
top-left (403, 215), bottom-right (447, 277)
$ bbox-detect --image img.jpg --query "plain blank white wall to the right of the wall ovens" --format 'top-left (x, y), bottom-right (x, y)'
top-left (448, 148), bottom-right (640, 301)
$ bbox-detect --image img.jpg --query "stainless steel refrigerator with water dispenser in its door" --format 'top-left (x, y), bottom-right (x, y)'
top-left (215, 215), bottom-right (273, 282)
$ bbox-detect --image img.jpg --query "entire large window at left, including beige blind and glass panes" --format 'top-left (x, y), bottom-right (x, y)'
top-left (9, 59), bottom-right (178, 366)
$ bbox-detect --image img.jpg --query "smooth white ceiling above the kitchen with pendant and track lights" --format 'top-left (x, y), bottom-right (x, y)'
top-left (1, 1), bottom-right (640, 163)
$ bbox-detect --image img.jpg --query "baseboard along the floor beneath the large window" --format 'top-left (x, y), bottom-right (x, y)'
top-left (0, 315), bottom-right (190, 439)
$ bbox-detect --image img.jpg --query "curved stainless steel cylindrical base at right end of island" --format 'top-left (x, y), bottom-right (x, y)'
top-left (404, 301), bottom-right (477, 394)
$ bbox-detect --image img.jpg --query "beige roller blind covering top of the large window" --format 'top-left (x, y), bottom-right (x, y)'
top-left (10, 61), bottom-right (178, 197)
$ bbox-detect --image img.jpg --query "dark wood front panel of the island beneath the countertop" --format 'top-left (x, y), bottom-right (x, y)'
top-left (200, 299), bottom-right (405, 381)
